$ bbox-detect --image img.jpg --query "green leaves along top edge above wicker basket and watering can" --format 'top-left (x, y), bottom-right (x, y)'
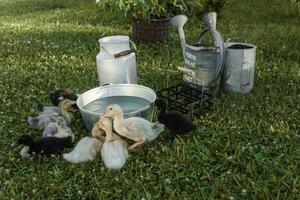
top-left (97, 0), bottom-right (228, 20)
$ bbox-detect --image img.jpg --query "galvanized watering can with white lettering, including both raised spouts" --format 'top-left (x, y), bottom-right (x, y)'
top-left (170, 12), bottom-right (225, 96)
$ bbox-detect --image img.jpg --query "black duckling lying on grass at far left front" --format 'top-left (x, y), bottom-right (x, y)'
top-left (15, 135), bottom-right (73, 157)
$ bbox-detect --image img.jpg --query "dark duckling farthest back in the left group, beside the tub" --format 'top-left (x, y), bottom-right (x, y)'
top-left (49, 89), bottom-right (78, 108)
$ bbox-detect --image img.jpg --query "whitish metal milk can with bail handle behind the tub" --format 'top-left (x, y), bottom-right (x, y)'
top-left (96, 35), bottom-right (137, 85)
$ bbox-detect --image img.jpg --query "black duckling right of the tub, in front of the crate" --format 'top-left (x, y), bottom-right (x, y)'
top-left (155, 98), bottom-right (195, 139)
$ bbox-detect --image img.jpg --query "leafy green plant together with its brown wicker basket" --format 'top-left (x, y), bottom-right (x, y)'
top-left (98, 0), bottom-right (187, 42)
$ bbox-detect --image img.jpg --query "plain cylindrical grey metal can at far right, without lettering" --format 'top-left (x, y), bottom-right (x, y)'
top-left (222, 39), bottom-right (256, 94)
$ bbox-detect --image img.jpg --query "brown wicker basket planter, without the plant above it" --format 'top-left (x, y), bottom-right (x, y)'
top-left (132, 18), bottom-right (170, 42)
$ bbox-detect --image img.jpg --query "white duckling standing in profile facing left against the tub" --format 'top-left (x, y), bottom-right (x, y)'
top-left (103, 104), bottom-right (165, 149)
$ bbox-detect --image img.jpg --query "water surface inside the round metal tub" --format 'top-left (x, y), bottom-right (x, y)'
top-left (83, 96), bottom-right (150, 114)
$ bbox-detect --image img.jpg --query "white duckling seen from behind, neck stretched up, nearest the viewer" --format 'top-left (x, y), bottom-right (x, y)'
top-left (99, 118), bottom-right (128, 169)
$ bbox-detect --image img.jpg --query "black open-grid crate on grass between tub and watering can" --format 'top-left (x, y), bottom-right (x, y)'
top-left (157, 83), bottom-right (213, 119)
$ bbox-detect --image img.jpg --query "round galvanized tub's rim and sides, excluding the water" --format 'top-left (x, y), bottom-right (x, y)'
top-left (77, 84), bottom-right (156, 131)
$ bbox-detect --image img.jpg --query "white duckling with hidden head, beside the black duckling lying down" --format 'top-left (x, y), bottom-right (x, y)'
top-left (63, 137), bottom-right (102, 163)
